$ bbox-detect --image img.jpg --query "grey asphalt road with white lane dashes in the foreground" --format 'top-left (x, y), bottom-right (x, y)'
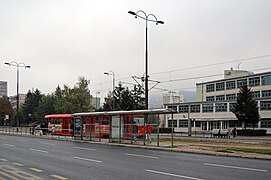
top-left (0, 135), bottom-right (271, 180)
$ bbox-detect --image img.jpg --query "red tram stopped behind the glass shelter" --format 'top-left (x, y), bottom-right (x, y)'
top-left (45, 112), bottom-right (152, 139)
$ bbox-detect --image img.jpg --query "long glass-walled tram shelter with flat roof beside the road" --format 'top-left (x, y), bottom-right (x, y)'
top-left (73, 109), bottom-right (177, 146)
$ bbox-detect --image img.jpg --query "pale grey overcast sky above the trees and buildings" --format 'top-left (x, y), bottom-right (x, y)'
top-left (0, 0), bottom-right (271, 103)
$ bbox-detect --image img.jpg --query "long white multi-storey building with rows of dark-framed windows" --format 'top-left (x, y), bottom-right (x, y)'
top-left (165, 69), bottom-right (271, 133)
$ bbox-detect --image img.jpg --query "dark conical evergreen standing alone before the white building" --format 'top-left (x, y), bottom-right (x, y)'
top-left (231, 84), bottom-right (260, 129)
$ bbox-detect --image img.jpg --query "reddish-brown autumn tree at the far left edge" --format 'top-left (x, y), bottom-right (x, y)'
top-left (0, 98), bottom-right (13, 125)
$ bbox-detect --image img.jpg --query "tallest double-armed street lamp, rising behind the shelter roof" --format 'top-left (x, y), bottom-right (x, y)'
top-left (128, 10), bottom-right (164, 109)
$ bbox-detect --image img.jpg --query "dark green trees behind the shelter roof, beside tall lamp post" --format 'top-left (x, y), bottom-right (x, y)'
top-left (101, 84), bottom-right (144, 111)
